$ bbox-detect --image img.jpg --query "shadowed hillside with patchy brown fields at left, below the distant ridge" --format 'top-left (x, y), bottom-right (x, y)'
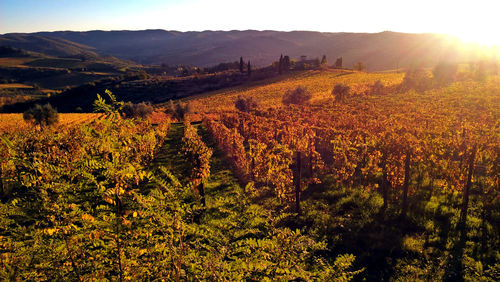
top-left (0, 47), bottom-right (137, 107)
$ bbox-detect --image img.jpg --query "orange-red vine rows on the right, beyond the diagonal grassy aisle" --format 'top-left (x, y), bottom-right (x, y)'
top-left (196, 74), bottom-right (500, 280)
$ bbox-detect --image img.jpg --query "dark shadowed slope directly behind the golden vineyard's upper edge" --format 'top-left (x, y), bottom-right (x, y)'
top-left (0, 69), bottom-right (254, 112)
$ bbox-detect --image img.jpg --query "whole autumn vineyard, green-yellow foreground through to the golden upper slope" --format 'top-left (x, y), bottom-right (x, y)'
top-left (0, 70), bottom-right (500, 281)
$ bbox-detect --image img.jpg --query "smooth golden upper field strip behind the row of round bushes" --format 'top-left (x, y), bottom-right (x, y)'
top-left (186, 70), bottom-right (404, 113)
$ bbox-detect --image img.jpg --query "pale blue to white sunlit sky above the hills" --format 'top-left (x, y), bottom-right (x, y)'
top-left (0, 0), bottom-right (500, 45)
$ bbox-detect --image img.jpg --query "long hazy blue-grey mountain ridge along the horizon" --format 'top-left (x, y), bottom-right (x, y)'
top-left (0, 30), bottom-right (498, 71)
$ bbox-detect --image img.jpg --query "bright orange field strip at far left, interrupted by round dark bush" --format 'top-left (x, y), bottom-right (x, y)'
top-left (0, 113), bottom-right (102, 133)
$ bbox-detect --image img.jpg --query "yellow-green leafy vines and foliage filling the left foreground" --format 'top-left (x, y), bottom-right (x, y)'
top-left (0, 92), bottom-right (360, 281)
